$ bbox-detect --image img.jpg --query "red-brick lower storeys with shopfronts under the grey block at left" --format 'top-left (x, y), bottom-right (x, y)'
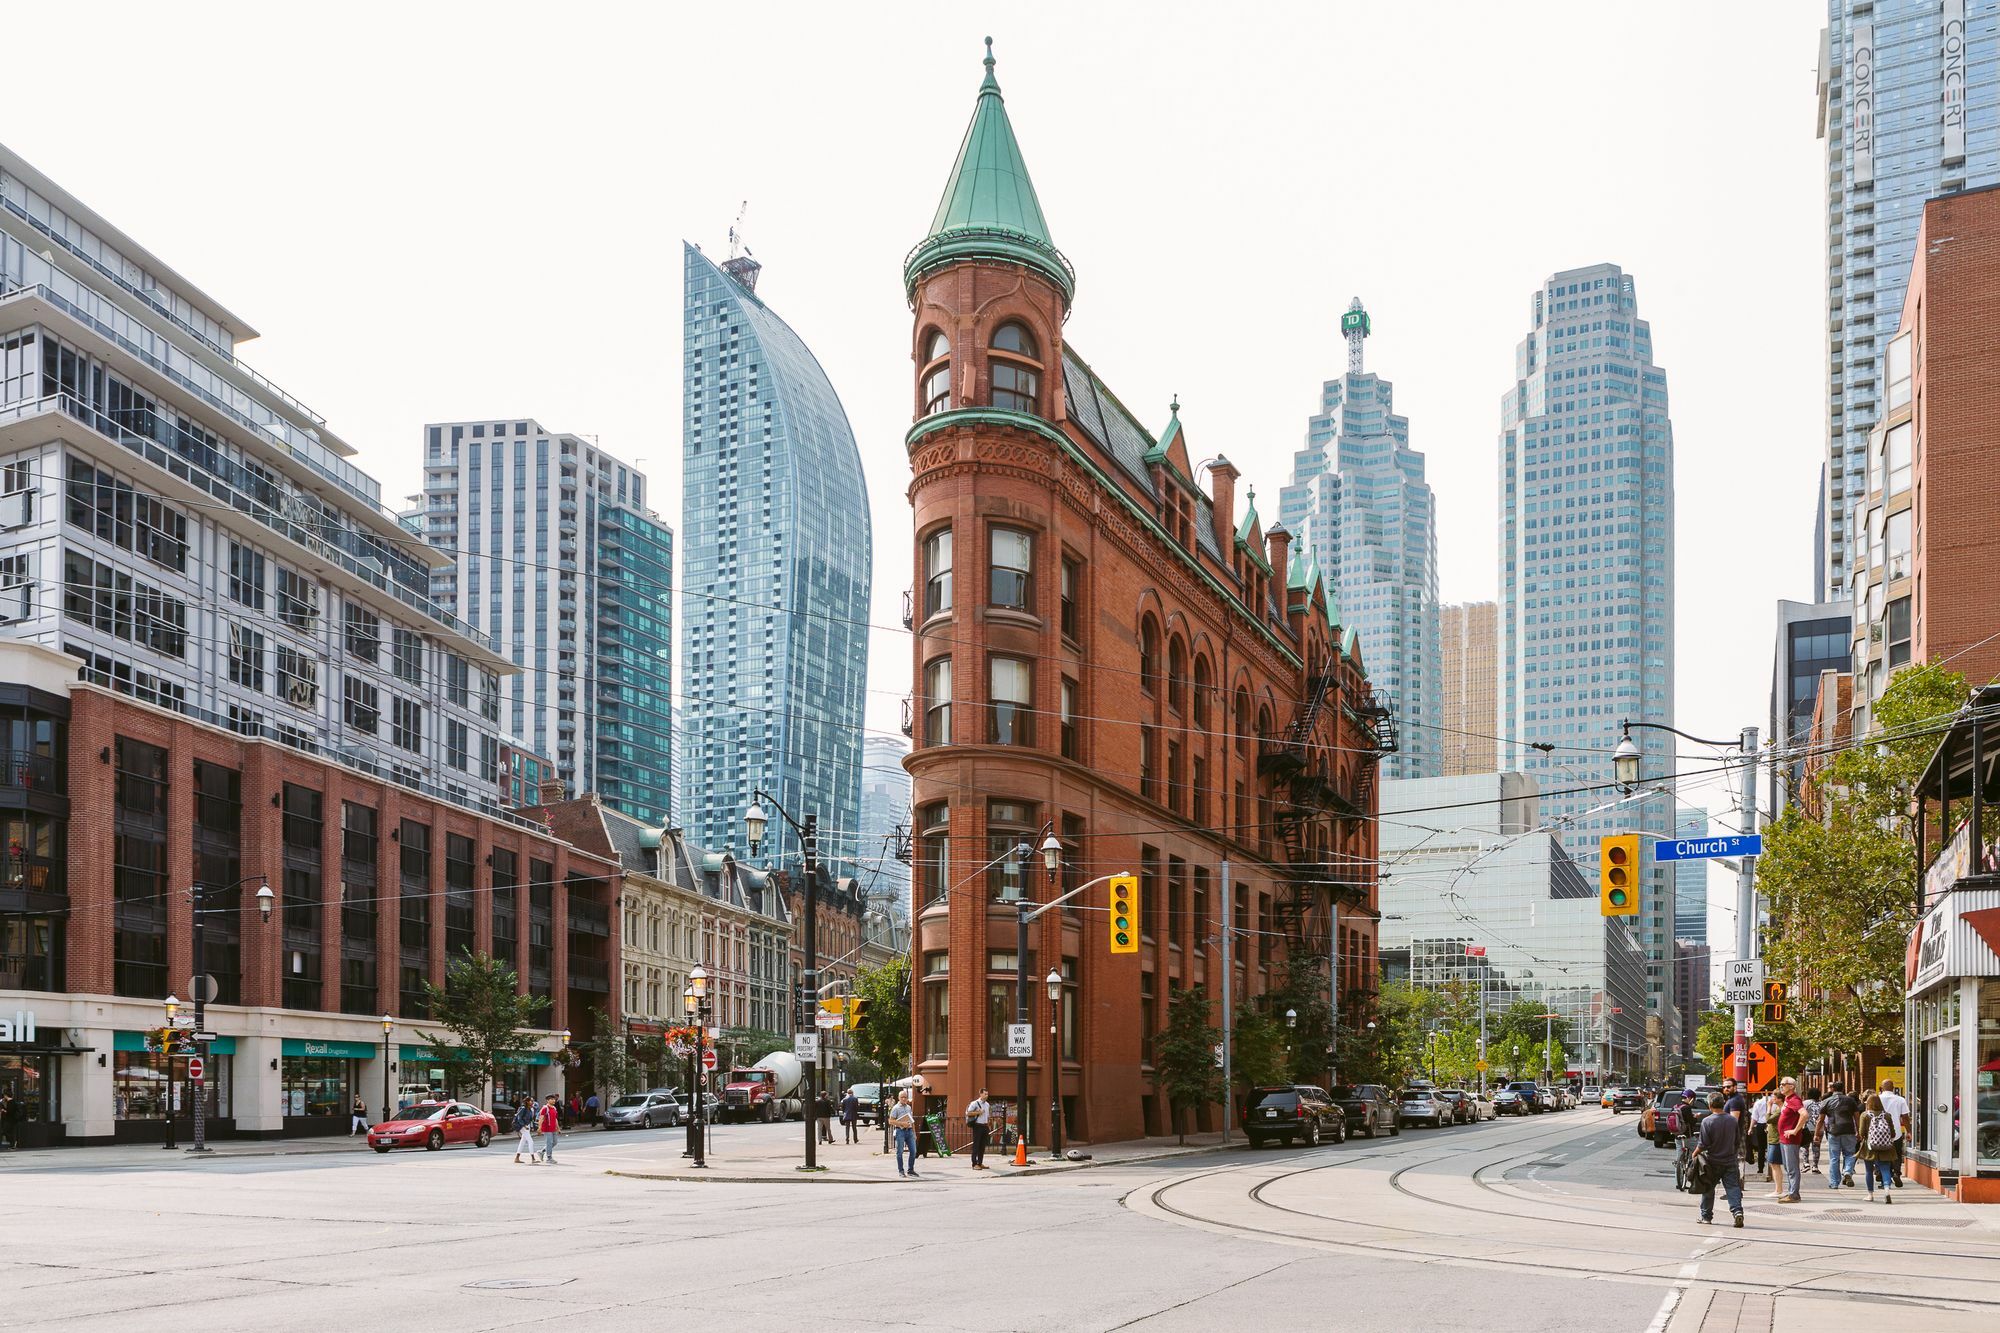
top-left (0, 642), bottom-right (618, 1143)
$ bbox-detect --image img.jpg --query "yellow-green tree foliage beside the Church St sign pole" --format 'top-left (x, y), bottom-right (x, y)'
top-left (1756, 667), bottom-right (1966, 1069)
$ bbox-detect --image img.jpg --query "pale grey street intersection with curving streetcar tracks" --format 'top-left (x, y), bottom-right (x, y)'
top-left (0, 1111), bottom-right (2000, 1333)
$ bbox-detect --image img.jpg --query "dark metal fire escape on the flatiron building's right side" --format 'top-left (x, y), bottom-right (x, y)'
top-left (1258, 660), bottom-right (1396, 972)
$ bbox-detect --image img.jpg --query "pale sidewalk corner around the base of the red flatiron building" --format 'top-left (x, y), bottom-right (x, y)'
top-left (590, 1131), bottom-right (1244, 1185)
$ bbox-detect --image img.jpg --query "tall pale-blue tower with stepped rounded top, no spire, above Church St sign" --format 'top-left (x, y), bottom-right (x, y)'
top-left (1500, 264), bottom-right (1678, 1056)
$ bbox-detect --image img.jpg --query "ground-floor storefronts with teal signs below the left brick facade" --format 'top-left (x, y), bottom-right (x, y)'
top-left (0, 991), bottom-right (564, 1147)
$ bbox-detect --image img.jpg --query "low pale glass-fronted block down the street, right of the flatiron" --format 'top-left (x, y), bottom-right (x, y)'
top-left (1382, 773), bottom-right (1678, 1081)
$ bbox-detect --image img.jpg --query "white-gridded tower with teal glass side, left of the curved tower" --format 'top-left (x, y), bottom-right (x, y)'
top-left (424, 418), bottom-right (674, 825)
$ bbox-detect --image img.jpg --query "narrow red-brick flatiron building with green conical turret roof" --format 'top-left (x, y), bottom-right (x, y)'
top-left (904, 44), bottom-right (1394, 1141)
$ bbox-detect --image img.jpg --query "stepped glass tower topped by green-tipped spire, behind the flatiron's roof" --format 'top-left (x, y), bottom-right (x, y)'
top-left (1278, 296), bottom-right (1440, 779)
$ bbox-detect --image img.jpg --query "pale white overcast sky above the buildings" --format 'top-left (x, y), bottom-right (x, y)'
top-left (0, 0), bottom-right (1826, 951)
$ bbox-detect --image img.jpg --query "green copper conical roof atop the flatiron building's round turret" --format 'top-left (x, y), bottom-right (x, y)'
top-left (902, 38), bottom-right (1076, 304)
